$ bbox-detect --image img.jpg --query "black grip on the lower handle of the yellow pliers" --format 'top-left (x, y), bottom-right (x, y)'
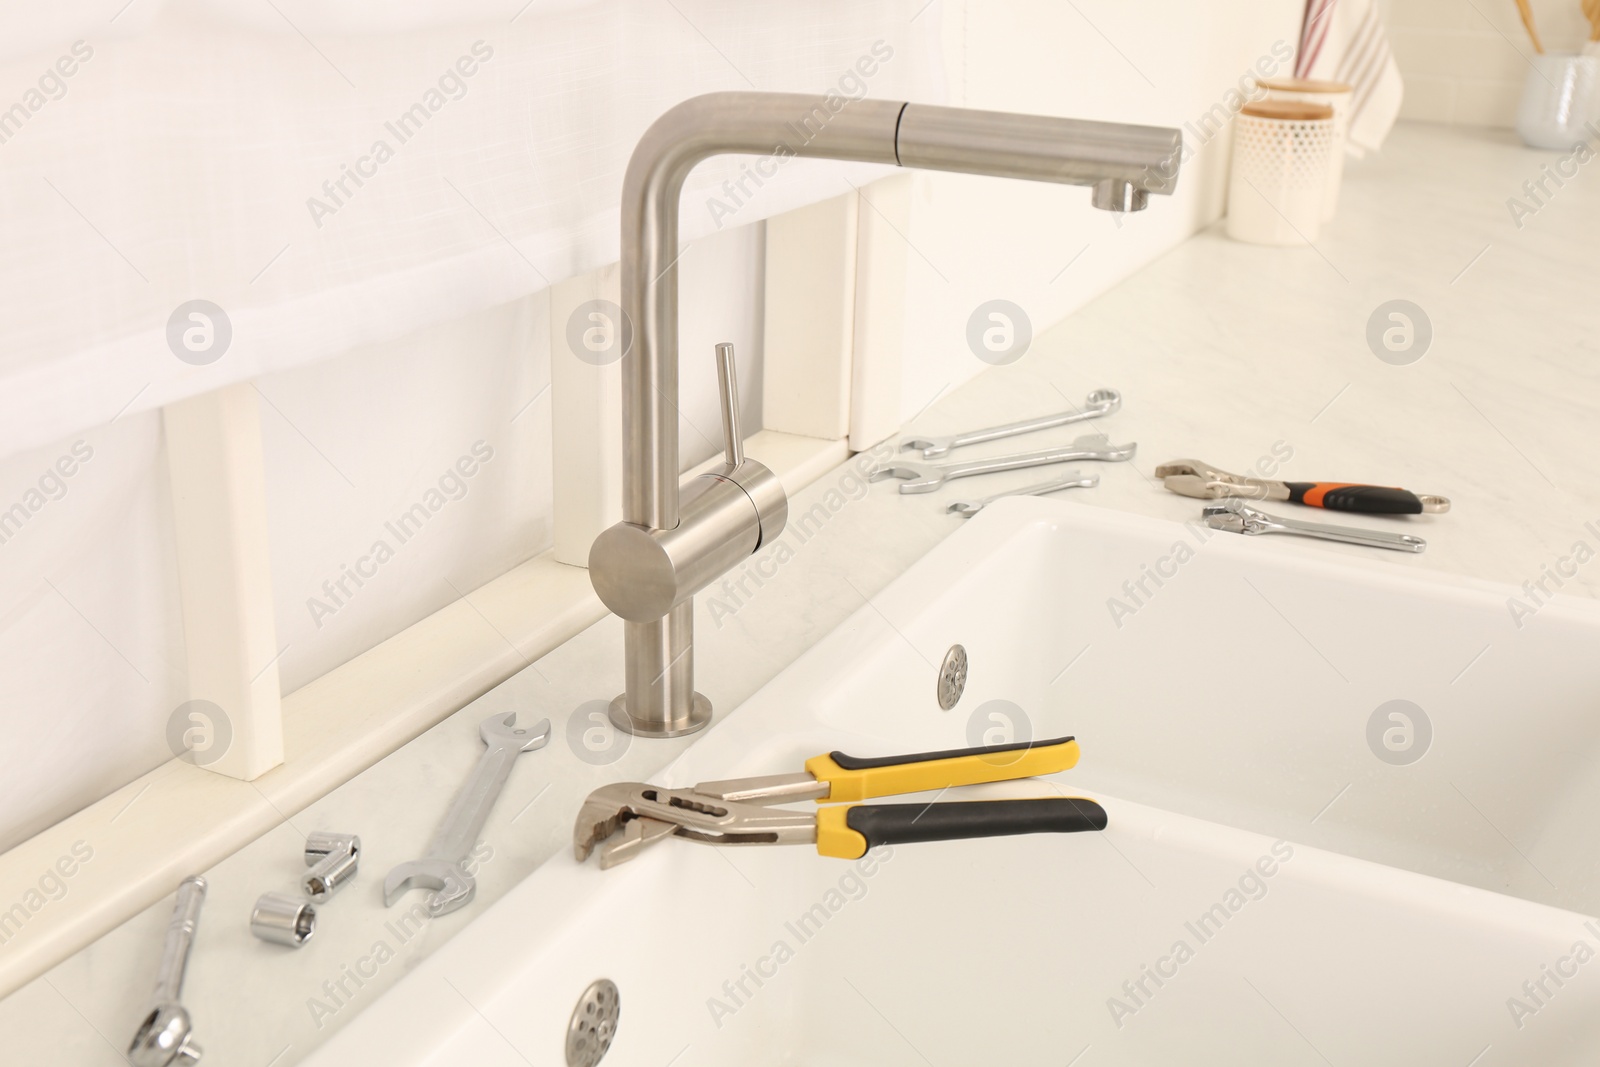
top-left (845, 797), bottom-right (1106, 848)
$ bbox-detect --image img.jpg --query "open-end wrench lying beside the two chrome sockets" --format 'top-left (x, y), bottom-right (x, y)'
top-left (384, 712), bottom-right (550, 918)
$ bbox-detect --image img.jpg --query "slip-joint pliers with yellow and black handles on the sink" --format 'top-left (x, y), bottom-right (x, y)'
top-left (573, 737), bottom-right (1106, 869)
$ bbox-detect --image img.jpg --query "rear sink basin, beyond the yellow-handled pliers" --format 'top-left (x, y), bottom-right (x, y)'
top-left (793, 501), bottom-right (1600, 913)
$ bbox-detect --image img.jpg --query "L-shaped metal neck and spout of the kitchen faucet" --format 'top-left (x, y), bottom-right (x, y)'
top-left (622, 93), bottom-right (1182, 530)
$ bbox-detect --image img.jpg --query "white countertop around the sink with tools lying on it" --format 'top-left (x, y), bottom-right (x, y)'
top-left (0, 126), bottom-right (1600, 1067)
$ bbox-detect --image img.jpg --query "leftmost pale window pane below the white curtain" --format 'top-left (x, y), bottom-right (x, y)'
top-left (0, 411), bottom-right (186, 851)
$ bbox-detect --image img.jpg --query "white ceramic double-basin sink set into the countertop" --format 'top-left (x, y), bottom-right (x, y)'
top-left (307, 499), bottom-right (1600, 1067)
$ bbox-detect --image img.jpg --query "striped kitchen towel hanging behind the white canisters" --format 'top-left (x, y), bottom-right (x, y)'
top-left (1294, 0), bottom-right (1405, 157)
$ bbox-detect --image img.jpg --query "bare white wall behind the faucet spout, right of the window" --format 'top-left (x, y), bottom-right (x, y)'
top-left (902, 0), bottom-right (1305, 418)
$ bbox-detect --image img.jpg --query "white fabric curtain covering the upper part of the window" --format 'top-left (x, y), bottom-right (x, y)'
top-left (0, 0), bottom-right (942, 467)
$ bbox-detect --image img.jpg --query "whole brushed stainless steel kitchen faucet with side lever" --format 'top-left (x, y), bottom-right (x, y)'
top-left (589, 93), bottom-right (1182, 737)
